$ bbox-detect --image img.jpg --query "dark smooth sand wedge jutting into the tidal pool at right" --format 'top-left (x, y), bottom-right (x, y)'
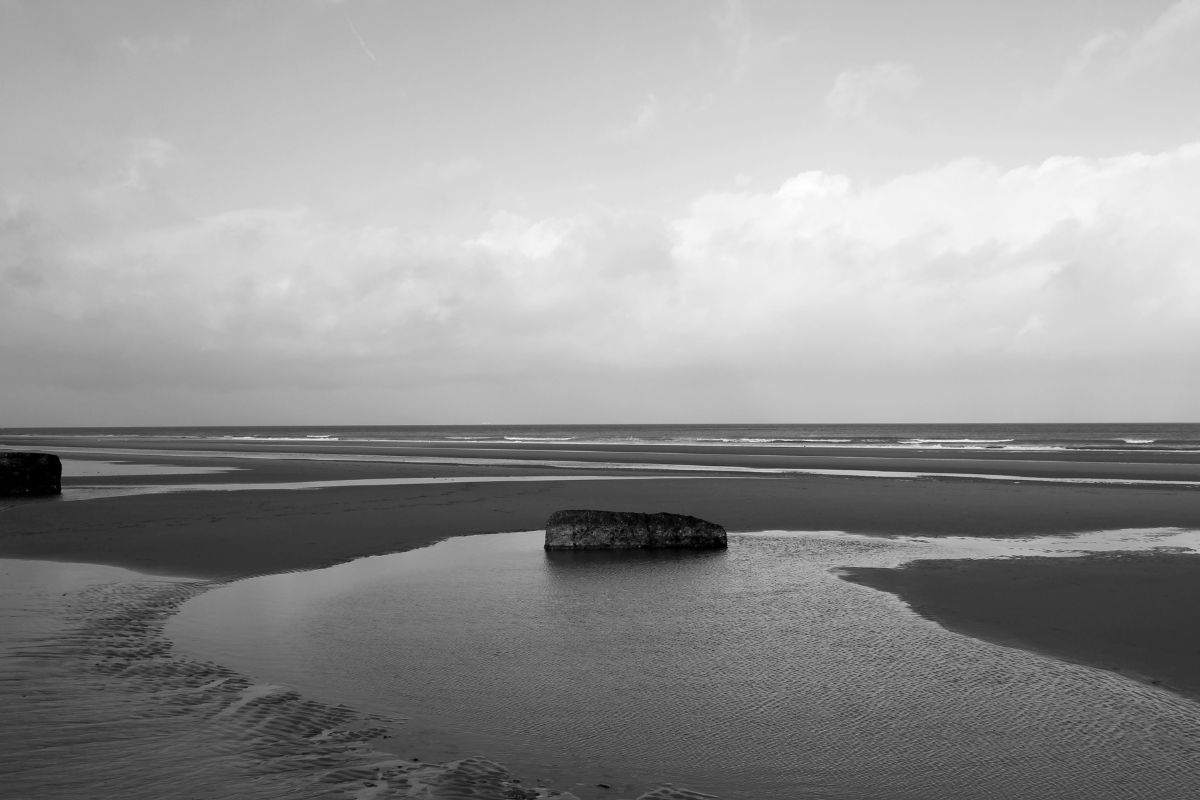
top-left (841, 553), bottom-right (1200, 700)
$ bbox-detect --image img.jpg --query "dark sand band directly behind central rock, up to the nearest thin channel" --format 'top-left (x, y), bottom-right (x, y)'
top-left (0, 468), bottom-right (1200, 579)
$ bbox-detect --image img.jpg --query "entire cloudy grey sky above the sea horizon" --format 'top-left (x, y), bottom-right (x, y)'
top-left (0, 0), bottom-right (1200, 427)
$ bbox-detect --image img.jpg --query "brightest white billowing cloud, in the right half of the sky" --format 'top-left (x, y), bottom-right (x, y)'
top-left (676, 146), bottom-right (1200, 367)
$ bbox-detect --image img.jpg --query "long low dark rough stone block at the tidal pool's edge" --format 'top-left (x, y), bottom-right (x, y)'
top-left (546, 511), bottom-right (727, 551)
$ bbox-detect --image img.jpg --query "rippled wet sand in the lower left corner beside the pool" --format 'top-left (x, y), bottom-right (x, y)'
top-left (0, 561), bottom-right (628, 800)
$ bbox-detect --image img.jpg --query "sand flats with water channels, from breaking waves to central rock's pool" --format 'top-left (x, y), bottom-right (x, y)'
top-left (7, 438), bottom-right (1200, 579)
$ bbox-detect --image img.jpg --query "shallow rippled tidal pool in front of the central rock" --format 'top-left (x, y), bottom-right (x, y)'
top-left (170, 534), bottom-right (1200, 800)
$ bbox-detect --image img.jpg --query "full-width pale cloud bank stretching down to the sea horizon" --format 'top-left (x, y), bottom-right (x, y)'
top-left (0, 143), bottom-right (1200, 423)
